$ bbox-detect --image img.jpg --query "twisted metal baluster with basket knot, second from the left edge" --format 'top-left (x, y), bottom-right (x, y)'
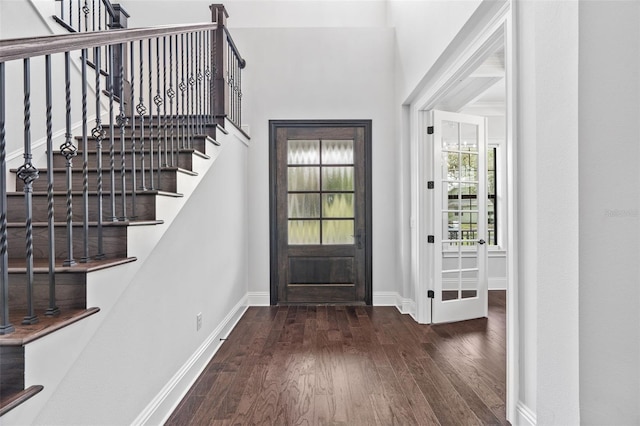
top-left (18, 58), bottom-right (39, 325)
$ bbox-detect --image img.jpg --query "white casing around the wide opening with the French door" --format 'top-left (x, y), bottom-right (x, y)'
top-left (402, 0), bottom-right (519, 423)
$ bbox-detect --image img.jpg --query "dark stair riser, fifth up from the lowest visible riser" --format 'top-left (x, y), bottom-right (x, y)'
top-left (16, 169), bottom-right (177, 193)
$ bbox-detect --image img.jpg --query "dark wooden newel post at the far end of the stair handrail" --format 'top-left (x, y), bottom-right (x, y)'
top-left (209, 4), bottom-right (229, 125)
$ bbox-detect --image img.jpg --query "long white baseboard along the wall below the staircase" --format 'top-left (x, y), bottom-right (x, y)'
top-left (131, 296), bottom-right (247, 425)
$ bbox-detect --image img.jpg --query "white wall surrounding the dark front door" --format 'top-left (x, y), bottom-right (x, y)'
top-left (233, 28), bottom-right (400, 294)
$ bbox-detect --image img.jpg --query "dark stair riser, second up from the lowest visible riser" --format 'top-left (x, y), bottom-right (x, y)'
top-left (9, 273), bottom-right (87, 315)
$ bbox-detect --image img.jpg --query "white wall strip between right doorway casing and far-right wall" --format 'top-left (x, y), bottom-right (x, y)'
top-left (516, 1), bottom-right (580, 425)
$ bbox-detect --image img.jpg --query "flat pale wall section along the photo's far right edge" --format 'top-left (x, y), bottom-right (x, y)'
top-left (578, 1), bottom-right (640, 425)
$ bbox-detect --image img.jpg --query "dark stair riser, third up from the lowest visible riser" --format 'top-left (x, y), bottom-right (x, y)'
top-left (8, 226), bottom-right (127, 261)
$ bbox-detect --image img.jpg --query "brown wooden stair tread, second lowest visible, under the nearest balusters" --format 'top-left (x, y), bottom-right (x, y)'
top-left (0, 307), bottom-right (100, 346)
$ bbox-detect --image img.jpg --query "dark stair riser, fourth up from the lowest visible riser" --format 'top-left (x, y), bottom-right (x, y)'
top-left (7, 193), bottom-right (157, 223)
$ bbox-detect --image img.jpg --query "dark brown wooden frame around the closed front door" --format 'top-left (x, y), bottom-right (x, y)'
top-left (269, 120), bottom-right (373, 305)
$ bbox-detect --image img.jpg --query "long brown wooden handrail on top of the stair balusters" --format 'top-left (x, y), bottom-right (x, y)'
top-left (0, 22), bottom-right (218, 62)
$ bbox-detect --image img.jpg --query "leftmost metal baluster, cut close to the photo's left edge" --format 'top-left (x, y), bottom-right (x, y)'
top-left (0, 62), bottom-right (15, 335)
